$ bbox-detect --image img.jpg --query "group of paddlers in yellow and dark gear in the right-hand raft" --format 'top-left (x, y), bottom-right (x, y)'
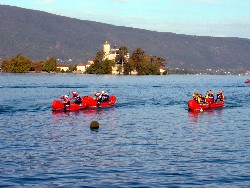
top-left (192, 90), bottom-right (225, 103)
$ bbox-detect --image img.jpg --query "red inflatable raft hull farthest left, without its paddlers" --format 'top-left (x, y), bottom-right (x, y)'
top-left (52, 100), bottom-right (88, 111)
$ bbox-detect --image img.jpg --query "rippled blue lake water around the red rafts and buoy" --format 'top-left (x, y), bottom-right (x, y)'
top-left (0, 73), bottom-right (250, 187)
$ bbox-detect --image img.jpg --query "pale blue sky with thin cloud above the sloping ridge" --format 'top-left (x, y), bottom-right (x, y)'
top-left (0, 0), bottom-right (250, 39)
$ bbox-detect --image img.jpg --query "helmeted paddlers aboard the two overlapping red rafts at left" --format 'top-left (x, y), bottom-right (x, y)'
top-left (60, 90), bottom-right (109, 108)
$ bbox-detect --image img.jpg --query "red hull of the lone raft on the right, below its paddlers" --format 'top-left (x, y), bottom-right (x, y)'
top-left (188, 100), bottom-right (224, 111)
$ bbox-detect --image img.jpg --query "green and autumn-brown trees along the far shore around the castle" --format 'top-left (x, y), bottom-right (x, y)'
top-left (1, 46), bottom-right (166, 75)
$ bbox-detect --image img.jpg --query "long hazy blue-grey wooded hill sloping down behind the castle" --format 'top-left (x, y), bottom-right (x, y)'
top-left (0, 5), bottom-right (250, 70)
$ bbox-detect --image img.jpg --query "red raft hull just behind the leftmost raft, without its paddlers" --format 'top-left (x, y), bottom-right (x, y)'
top-left (82, 95), bottom-right (116, 107)
